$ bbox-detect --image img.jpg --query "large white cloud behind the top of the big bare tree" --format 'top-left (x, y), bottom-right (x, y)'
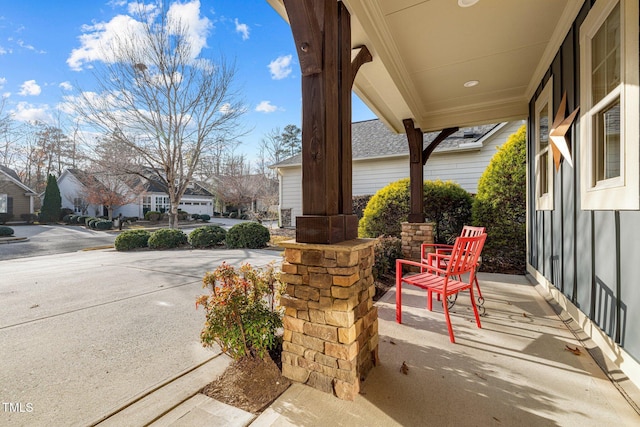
top-left (67, 0), bottom-right (213, 71)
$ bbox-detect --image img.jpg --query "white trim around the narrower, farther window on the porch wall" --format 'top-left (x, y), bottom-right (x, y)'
top-left (533, 76), bottom-right (555, 211)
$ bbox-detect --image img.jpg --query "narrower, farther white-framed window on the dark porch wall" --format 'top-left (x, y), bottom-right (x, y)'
top-left (534, 78), bottom-right (553, 210)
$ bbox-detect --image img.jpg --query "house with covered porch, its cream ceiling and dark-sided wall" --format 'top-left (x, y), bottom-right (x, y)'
top-left (268, 0), bottom-right (640, 392)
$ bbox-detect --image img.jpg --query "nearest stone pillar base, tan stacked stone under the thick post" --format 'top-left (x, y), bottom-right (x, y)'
top-left (280, 239), bottom-right (378, 400)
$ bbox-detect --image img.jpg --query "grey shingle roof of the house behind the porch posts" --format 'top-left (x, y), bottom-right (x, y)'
top-left (270, 119), bottom-right (500, 168)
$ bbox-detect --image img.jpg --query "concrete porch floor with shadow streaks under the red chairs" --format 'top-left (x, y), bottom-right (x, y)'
top-left (252, 273), bottom-right (640, 426)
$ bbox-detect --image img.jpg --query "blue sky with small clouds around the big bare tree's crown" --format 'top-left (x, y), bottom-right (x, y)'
top-left (0, 0), bottom-right (374, 163)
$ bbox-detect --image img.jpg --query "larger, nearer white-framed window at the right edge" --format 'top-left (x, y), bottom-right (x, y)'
top-left (580, 0), bottom-right (640, 210)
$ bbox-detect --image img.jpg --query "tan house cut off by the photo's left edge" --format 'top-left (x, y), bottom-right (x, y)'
top-left (0, 166), bottom-right (38, 223)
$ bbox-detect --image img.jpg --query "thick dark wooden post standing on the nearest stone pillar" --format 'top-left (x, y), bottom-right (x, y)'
top-left (284, 0), bottom-right (371, 244)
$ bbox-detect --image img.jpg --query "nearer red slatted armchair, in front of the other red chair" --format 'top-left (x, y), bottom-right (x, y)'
top-left (396, 234), bottom-right (487, 343)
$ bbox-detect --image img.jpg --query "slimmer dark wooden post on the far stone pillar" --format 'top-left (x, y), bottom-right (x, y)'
top-left (402, 119), bottom-right (424, 223)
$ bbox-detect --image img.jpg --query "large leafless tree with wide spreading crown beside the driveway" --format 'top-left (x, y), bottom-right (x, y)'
top-left (74, 3), bottom-right (246, 227)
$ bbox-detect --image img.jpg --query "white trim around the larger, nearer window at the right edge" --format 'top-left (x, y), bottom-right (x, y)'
top-left (580, 0), bottom-right (640, 210)
